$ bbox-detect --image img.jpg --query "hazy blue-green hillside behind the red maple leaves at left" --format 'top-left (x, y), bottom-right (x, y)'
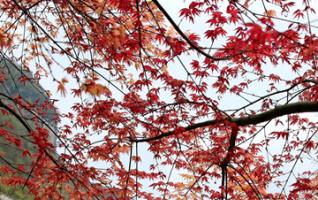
top-left (0, 58), bottom-right (57, 199)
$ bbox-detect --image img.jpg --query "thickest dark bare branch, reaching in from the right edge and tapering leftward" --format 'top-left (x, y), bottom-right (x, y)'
top-left (131, 102), bottom-right (318, 142)
